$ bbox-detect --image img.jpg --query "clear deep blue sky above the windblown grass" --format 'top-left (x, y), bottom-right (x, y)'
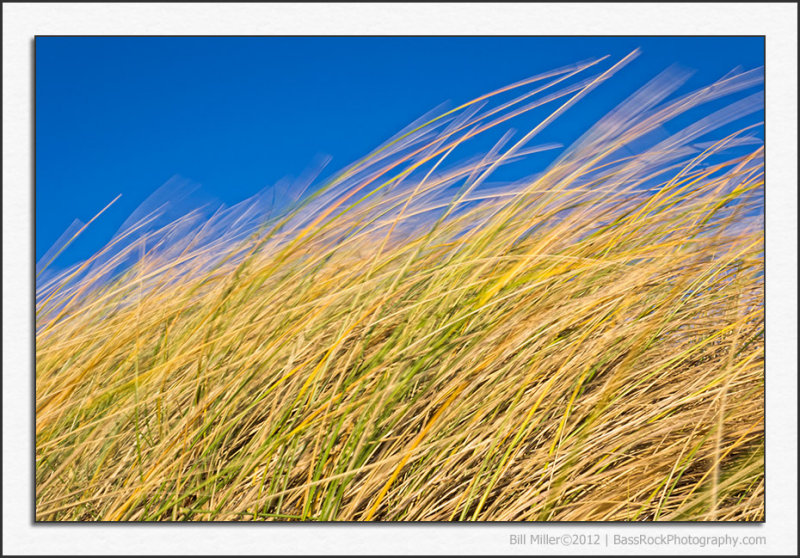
top-left (36, 37), bottom-right (764, 267)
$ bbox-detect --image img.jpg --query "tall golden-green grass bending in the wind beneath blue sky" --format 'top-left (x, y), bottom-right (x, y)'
top-left (36, 57), bottom-right (764, 521)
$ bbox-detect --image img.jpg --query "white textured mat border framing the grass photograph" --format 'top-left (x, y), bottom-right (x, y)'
top-left (3, 3), bottom-right (797, 554)
